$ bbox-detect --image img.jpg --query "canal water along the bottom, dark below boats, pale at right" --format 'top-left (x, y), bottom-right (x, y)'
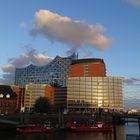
top-left (0, 123), bottom-right (139, 140)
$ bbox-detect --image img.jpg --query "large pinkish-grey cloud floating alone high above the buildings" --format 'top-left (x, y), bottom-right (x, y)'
top-left (31, 10), bottom-right (111, 51)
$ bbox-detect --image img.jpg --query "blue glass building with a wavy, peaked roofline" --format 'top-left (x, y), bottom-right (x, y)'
top-left (15, 54), bottom-right (77, 88)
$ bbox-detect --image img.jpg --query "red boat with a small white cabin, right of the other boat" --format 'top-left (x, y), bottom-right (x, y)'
top-left (70, 122), bottom-right (112, 132)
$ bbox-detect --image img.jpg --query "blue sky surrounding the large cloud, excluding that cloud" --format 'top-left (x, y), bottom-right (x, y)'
top-left (0, 0), bottom-right (140, 109)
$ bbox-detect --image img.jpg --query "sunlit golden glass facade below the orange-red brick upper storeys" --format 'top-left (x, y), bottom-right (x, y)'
top-left (67, 77), bottom-right (123, 110)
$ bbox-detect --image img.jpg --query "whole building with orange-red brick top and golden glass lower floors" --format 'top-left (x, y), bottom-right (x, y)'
top-left (67, 58), bottom-right (123, 110)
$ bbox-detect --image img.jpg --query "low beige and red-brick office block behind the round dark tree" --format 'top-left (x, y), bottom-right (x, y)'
top-left (24, 84), bottom-right (67, 111)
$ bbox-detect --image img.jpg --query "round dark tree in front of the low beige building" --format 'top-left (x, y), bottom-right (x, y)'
top-left (34, 97), bottom-right (51, 113)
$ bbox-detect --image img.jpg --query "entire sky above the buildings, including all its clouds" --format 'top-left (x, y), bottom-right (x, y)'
top-left (0, 0), bottom-right (140, 108)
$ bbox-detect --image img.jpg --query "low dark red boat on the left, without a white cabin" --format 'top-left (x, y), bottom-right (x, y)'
top-left (16, 125), bottom-right (54, 133)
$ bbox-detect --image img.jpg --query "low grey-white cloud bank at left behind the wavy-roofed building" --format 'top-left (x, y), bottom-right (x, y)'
top-left (0, 47), bottom-right (52, 84)
